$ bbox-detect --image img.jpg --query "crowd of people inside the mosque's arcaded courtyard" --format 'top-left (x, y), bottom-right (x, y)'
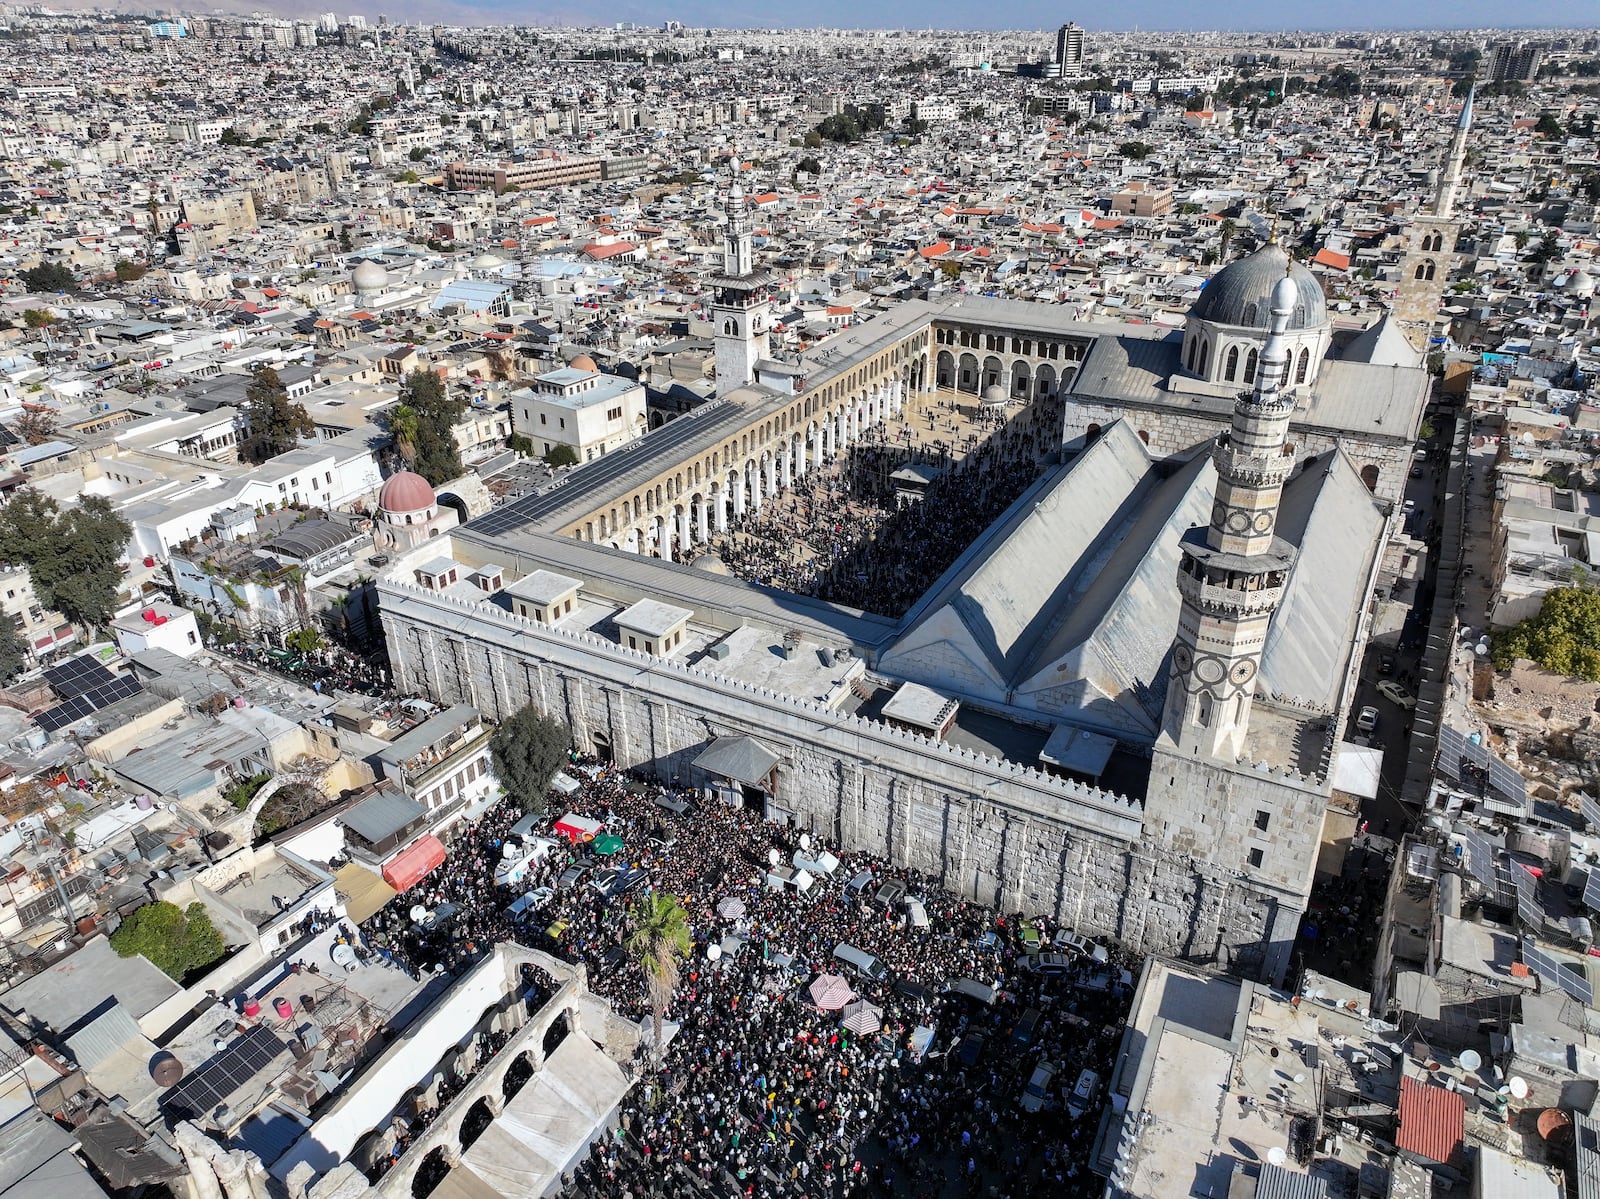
top-left (712, 399), bottom-right (1062, 616)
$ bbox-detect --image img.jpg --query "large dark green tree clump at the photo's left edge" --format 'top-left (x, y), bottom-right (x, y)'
top-left (0, 487), bottom-right (133, 629)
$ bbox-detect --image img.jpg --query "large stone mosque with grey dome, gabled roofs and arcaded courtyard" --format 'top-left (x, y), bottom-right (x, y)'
top-left (378, 164), bottom-right (1429, 981)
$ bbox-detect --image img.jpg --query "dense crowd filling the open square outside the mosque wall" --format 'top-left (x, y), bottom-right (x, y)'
top-left (363, 762), bottom-right (1134, 1199)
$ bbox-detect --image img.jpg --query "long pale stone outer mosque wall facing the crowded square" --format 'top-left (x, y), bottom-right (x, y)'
top-left (379, 578), bottom-right (1317, 967)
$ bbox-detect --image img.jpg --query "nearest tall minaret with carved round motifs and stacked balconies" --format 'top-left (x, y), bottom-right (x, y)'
top-left (1162, 272), bottom-right (1298, 762)
